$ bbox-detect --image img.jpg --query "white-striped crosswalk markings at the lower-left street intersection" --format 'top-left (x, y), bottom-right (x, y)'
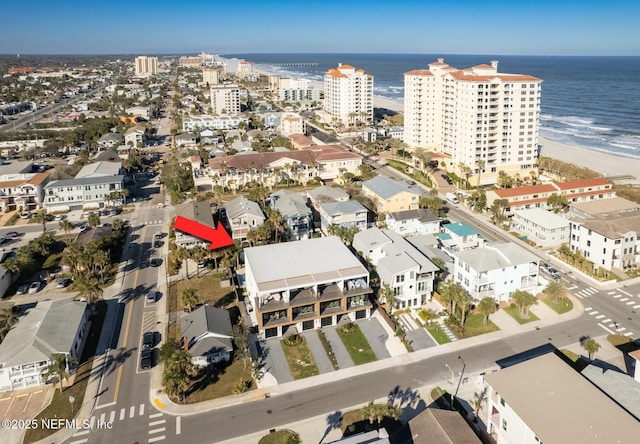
top-left (69, 404), bottom-right (172, 444)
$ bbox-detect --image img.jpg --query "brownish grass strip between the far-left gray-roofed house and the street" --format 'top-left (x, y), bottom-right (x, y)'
top-left (24, 301), bottom-right (107, 443)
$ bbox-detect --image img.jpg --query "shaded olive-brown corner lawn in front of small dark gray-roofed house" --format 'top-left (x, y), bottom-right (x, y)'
top-left (185, 359), bottom-right (255, 404)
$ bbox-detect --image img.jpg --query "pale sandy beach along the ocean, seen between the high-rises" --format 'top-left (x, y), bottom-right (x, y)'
top-left (256, 66), bottom-right (640, 184)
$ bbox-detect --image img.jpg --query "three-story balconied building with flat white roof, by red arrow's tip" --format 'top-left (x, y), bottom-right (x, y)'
top-left (244, 236), bottom-right (373, 338)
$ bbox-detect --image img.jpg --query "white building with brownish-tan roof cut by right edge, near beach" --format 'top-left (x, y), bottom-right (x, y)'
top-left (569, 209), bottom-right (640, 271)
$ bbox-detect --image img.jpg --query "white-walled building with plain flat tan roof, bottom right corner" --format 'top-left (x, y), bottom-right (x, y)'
top-left (484, 353), bottom-right (640, 444)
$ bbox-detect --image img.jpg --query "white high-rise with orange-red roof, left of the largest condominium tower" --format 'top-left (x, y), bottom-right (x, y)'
top-left (324, 63), bottom-right (373, 125)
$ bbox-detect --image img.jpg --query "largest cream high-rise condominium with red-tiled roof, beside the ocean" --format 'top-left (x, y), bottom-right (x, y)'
top-left (404, 59), bottom-right (542, 185)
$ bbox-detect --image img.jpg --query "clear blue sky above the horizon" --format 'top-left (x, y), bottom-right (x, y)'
top-left (5, 0), bottom-right (640, 55)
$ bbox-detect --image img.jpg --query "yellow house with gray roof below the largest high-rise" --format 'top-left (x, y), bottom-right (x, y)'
top-left (362, 176), bottom-right (421, 213)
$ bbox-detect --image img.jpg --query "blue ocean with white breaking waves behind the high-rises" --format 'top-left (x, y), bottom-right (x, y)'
top-left (223, 53), bottom-right (640, 158)
